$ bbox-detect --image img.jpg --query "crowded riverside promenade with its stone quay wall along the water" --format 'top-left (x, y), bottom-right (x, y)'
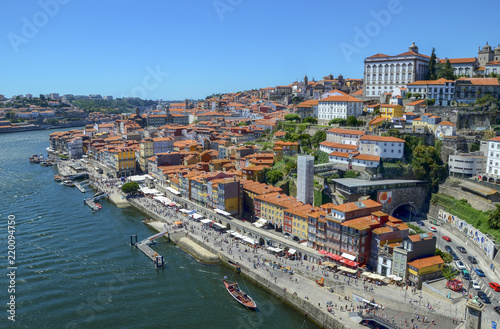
top-left (72, 164), bottom-right (463, 328)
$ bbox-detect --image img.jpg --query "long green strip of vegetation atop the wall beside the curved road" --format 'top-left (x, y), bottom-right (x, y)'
top-left (431, 193), bottom-right (500, 241)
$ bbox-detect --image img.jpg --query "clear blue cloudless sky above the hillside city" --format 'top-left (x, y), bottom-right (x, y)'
top-left (0, 0), bottom-right (500, 100)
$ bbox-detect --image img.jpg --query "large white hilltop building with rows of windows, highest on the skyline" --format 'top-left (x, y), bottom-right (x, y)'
top-left (363, 43), bottom-right (430, 99)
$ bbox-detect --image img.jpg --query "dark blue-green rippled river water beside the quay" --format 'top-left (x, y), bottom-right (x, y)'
top-left (0, 130), bottom-right (316, 328)
